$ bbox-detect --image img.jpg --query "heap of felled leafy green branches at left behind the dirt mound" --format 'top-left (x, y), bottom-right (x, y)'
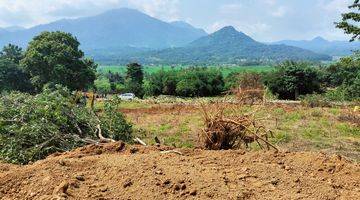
top-left (0, 86), bottom-right (131, 164)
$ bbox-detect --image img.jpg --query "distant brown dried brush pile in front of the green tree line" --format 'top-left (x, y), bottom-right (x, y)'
top-left (230, 73), bottom-right (265, 105)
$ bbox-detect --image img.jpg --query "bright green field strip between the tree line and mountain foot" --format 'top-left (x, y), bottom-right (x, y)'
top-left (97, 65), bottom-right (274, 76)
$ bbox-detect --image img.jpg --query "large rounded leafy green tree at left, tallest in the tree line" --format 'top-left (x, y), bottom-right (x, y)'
top-left (21, 31), bottom-right (96, 91)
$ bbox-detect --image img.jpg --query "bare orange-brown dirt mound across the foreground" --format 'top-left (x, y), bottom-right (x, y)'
top-left (0, 143), bottom-right (360, 199)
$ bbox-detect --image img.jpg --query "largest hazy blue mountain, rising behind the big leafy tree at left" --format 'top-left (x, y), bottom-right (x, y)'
top-left (0, 8), bottom-right (206, 52)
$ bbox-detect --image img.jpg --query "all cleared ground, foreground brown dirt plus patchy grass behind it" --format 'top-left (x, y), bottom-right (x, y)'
top-left (0, 97), bottom-right (360, 200)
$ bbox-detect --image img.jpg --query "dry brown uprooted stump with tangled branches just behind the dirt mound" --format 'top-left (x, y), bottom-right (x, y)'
top-left (200, 104), bottom-right (277, 150)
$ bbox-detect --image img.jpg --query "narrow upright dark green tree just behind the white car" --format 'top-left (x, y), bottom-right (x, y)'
top-left (125, 63), bottom-right (144, 98)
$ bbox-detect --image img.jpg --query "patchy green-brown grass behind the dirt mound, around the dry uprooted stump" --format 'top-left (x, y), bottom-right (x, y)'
top-left (101, 99), bottom-right (360, 161)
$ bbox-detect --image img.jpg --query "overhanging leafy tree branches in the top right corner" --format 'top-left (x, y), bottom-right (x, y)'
top-left (335, 0), bottom-right (360, 41)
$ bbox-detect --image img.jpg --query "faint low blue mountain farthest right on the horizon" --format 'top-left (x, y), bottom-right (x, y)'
top-left (273, 37), bottom-right (360, 56)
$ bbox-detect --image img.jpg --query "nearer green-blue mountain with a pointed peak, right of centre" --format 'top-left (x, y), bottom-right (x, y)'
top-left (124, 26), bottom-right (331, 64)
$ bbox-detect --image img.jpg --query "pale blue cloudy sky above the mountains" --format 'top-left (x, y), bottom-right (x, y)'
top-left (0, 0), bottom-right (353, 42)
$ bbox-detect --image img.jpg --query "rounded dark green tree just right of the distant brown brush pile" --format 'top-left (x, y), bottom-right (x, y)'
top-left (264, 61), bottom-right (321, 100)
